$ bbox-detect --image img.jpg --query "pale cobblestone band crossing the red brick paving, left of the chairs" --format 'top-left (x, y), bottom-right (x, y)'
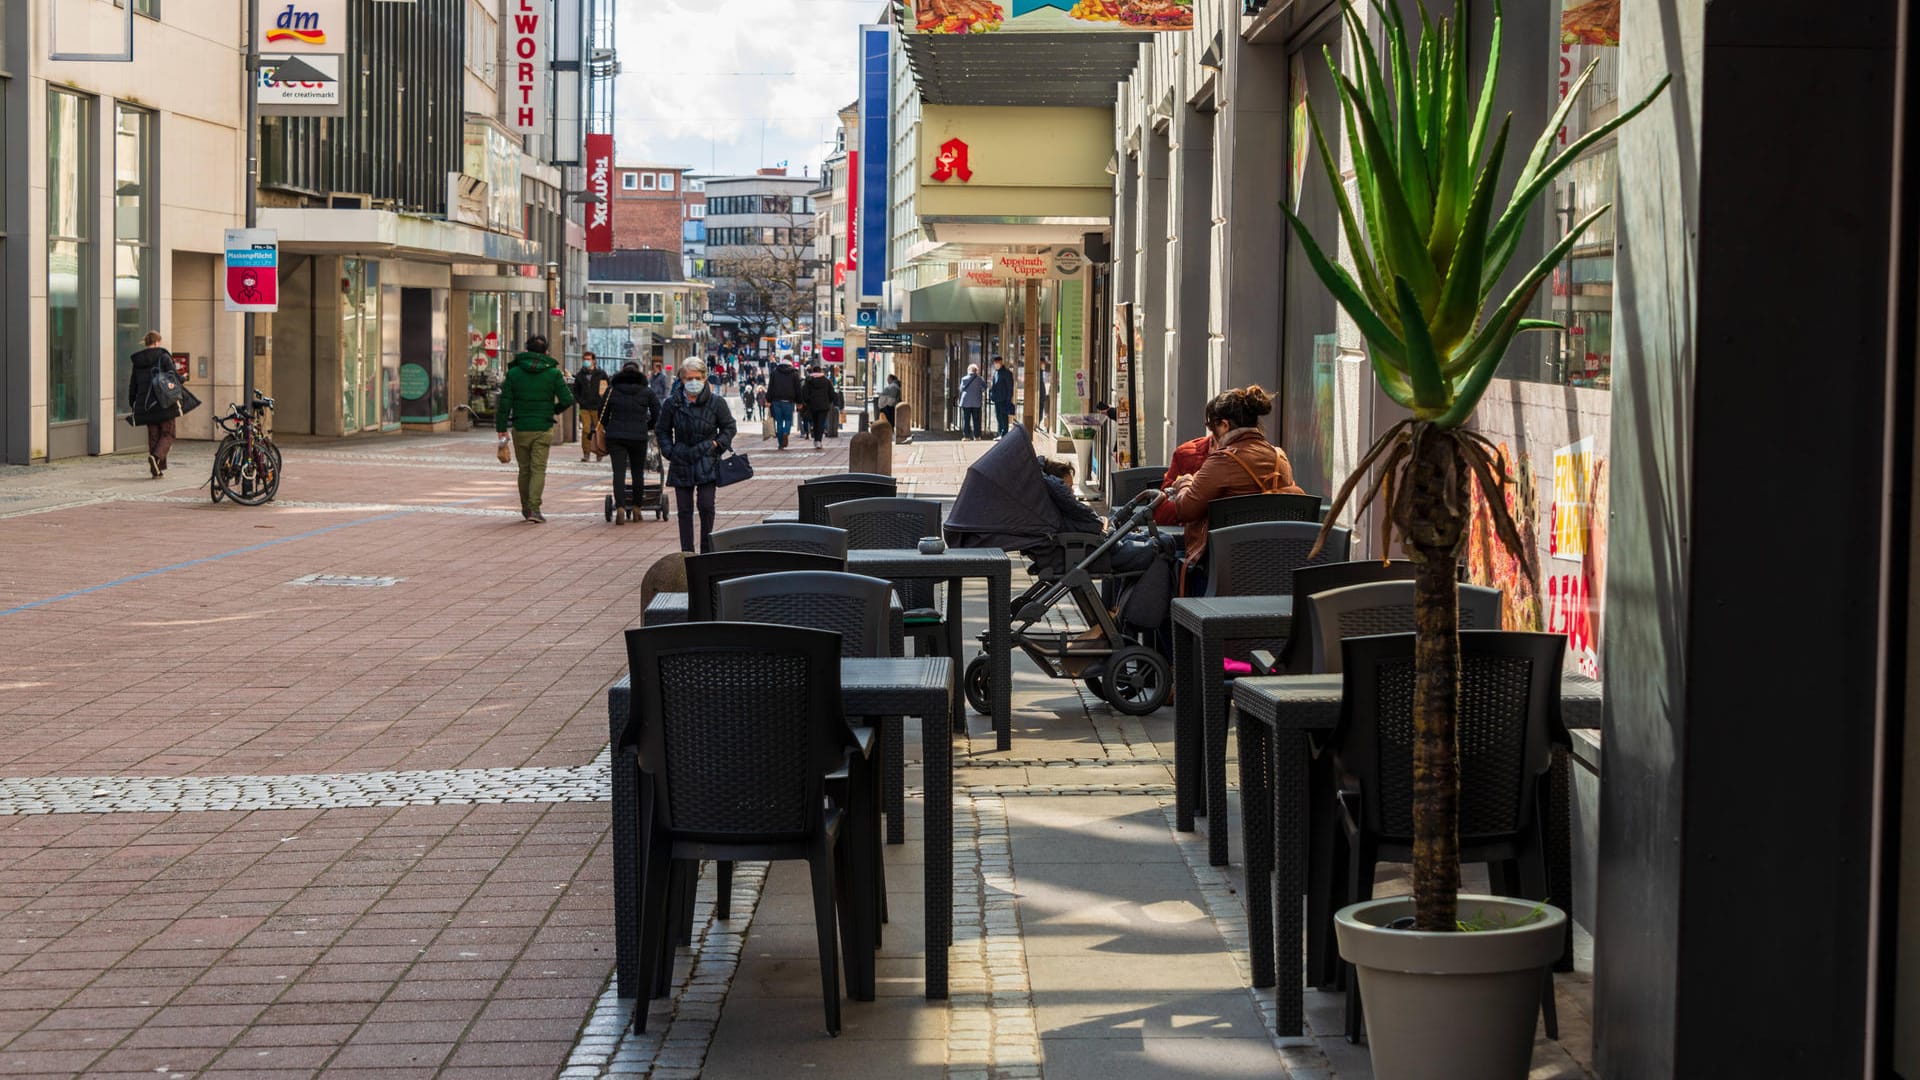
top-left (0, 748), bottom-right (612, 817)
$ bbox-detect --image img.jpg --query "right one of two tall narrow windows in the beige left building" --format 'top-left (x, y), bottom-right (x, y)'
top-left (113, 106), bottom-right (159, 415)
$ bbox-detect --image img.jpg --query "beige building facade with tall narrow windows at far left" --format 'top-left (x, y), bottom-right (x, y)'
top-left (0, 0), bottom-right (246, 457)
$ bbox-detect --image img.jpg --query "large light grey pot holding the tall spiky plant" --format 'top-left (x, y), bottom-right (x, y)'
top-left (1334, 896), bottom-right (1567, 1080)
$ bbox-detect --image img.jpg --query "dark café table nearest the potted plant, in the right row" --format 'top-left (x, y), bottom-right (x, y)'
top-left (1233, 673), bottom-right (1599, 1036)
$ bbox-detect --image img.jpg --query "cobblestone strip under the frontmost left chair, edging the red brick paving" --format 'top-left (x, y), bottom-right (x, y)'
top-left (561, 863), bottom-right (766, 1080)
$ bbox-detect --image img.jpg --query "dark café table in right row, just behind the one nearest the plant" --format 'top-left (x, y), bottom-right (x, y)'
top-left (1173, 596), bottom-right (1294, 867)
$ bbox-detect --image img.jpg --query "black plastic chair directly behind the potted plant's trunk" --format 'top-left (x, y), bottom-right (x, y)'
top-left (1325, 630), bottom-right (1571, 1042)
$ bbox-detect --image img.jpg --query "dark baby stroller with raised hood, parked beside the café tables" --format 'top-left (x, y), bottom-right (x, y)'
top-left (947, 429), bottom-right (1173, 717)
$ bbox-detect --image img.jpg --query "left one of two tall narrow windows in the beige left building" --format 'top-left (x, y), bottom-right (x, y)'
top-left (46, 90), bottom-right (92, 423)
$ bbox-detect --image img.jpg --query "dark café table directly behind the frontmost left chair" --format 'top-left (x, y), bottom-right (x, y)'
top-left (607, 645), bottom-right (960, 997)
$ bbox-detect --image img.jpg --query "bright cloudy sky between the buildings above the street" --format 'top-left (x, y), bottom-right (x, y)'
top-left (614, 0), bottom-right (885, 175)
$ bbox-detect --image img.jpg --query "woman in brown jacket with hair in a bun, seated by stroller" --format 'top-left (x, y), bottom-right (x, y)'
top-left (1164, 386), bottom-right (1304, 596)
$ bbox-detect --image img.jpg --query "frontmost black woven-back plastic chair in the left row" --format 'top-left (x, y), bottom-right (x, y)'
top-left (616, 623), bottom-right (872, 1034)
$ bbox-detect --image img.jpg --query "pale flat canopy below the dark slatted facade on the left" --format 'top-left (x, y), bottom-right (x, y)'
top-left (259, 206), bottom-right (543, 265)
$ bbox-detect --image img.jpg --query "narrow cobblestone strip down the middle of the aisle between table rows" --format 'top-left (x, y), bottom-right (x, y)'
top-left (947, 796), bottom-right (1041, 1080)
